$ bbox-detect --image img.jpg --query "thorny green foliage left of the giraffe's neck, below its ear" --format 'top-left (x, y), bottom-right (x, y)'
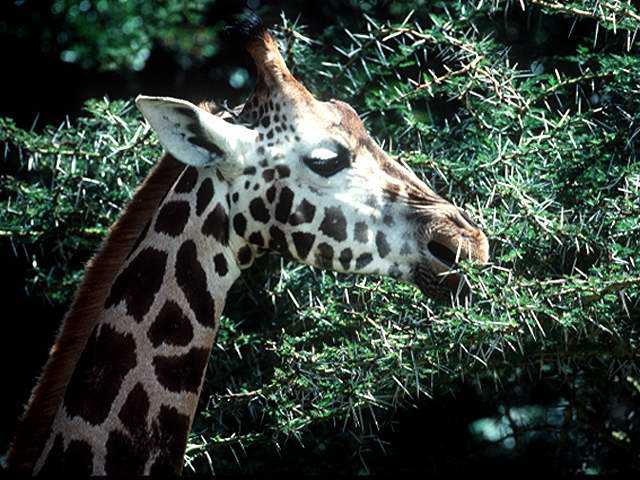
top-left (0, 100), bottom-right (161, 304)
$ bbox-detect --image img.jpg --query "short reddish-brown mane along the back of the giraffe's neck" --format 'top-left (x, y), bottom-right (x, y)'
top-left (7, 102), bottom-right (220, 473)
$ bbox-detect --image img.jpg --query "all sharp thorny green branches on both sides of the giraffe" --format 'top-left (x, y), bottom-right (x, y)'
top-left (0, 0), bottom-right (640, 473)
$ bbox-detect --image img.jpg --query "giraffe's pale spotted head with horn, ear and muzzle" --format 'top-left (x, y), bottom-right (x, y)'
top-left (136, 29), bottom-right (489, 295)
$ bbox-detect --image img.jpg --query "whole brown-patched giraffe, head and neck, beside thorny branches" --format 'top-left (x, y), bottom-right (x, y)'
top-left (8, 16), bottom-right (489, 475)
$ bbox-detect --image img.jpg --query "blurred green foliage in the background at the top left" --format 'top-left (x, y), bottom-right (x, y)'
top-left (0, 0), bottom-right (220, 71)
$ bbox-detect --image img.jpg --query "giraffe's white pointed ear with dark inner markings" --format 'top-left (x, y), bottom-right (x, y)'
top-left (136, 95), bottom-right (257, 171)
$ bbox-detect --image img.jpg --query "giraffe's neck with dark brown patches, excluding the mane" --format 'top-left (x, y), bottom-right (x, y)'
top-left (34, 168), bottom-right (240, 475)
